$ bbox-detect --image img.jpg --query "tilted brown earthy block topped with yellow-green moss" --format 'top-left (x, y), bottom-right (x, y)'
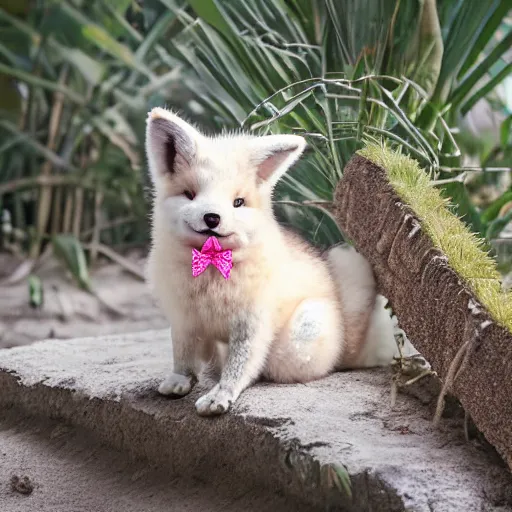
top-left (334, 145), bottom-right (512, 468)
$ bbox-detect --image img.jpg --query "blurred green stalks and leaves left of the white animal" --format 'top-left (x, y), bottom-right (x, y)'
top-left (0, 0), bottom-right (202, 286)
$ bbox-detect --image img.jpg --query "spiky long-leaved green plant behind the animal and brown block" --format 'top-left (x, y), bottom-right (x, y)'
top-left (166, 0), bottom-right (512, 254)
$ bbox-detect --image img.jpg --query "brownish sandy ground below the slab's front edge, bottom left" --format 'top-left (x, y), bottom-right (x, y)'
top-left (0, 412), bottom-right (311, 512)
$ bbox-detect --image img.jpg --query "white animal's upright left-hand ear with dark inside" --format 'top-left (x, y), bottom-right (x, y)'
top-left (146, 108), bottom-right (201, 180)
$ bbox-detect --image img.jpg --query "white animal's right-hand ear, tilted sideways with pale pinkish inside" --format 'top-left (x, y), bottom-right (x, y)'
top-left (250, 135), bottom-right (306, 187)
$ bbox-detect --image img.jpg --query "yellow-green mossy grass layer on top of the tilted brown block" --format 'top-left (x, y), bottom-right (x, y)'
top-left (358, 143), bottom-right (512, 332)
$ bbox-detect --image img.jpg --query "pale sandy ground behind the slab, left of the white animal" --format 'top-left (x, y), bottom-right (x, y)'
top-left (0, 253), bottom-right (168, 348)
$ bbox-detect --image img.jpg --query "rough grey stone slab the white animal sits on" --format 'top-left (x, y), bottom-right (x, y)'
top-left (0, 331), bottom-right (512, 512)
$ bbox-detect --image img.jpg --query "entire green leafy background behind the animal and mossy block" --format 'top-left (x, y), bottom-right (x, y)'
top-left (0, 0), bottom-right (512, 288)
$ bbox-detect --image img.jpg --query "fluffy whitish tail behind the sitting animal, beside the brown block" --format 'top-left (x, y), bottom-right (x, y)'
top-left (327, 245), bottom-right (415, 369)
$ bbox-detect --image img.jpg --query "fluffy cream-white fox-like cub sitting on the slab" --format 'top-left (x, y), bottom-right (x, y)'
top-left (146, 108), bottom-right (404, 415)
